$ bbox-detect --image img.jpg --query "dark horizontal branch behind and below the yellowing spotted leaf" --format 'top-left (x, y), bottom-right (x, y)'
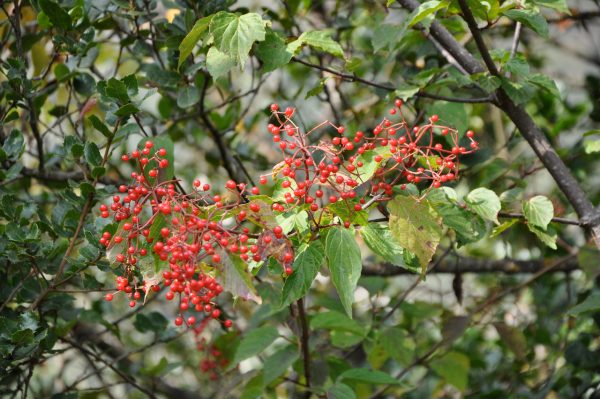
top-left (362, 256), bottom-right (579, 276)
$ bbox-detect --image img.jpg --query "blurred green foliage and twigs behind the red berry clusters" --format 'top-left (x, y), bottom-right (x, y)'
top-left (0, 0), bottom-right (600, 398)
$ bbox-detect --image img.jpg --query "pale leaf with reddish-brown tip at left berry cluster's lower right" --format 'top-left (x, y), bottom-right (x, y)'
top-left (217, 251), bottom-right (262, 304)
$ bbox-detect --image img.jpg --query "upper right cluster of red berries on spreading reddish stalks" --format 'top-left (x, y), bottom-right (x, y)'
top-left (260, 100), bottom-right (478, 227)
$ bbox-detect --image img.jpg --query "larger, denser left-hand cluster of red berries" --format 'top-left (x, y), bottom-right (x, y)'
top-left (100, 141), bottom-right (270, 327)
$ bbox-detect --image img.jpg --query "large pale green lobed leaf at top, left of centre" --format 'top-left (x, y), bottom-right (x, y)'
top-left (210, 11), bottom-right (266, 68)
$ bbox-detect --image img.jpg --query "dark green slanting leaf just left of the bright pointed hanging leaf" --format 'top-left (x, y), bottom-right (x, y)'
top-left (281, 241), bottom-right (325, 306)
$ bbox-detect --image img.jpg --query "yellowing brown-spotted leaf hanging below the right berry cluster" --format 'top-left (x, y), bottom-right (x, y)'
top-left (388, 196), bottom-right (442, 275)
